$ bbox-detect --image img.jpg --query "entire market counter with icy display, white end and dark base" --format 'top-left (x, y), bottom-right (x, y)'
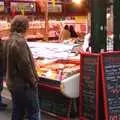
top-left (28, 42), bottom-right (80, 119)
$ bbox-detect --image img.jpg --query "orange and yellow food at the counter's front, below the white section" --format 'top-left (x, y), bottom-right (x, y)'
top-left (36, 61), bottom-right (80, 80)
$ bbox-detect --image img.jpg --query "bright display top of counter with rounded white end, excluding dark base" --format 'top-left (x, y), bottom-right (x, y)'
top-left (28, 42), bottom-right (80, 98)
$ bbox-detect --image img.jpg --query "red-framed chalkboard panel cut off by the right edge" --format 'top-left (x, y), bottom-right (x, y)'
top-left (101, 52), bottom-right (120, 120)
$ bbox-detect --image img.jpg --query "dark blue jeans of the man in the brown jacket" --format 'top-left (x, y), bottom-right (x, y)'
top-left (10, 87), bottom-right (41, 120)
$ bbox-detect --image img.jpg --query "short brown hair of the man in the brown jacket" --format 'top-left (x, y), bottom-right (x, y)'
top-left (10, 15), bottom-right (29, 33)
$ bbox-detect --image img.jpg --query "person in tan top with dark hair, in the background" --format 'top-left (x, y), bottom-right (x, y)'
top-left (59, 25), bottom-right (70, 41)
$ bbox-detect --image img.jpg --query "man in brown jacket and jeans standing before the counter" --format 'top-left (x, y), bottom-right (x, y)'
top-left (3, 15), bottom-right (41, 120)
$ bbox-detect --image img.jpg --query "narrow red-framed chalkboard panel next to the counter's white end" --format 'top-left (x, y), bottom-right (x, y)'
top-left (80, 54), bottom-right (99, 120)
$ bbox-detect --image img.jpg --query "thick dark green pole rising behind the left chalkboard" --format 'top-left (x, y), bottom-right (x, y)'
top-left (91, 0), bottom-right (106, 53)
